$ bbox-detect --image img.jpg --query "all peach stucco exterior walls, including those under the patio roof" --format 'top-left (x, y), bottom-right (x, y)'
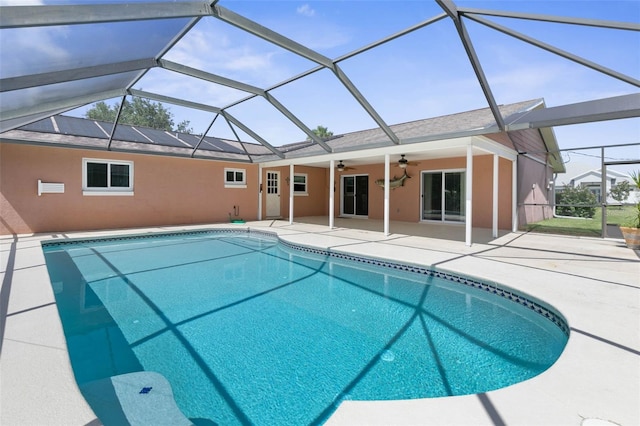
top-left (0, 143), bottom-right (536, 234)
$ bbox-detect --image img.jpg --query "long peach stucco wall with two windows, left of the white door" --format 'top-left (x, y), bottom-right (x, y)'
top-left (0, 143), bottom-right (258, 235)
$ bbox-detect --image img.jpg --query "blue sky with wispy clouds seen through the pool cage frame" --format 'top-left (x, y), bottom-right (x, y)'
top-left (0, 0), bottom-right (640, 173)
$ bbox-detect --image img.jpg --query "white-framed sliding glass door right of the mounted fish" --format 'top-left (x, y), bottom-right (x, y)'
top-left (422, 171), bottom-right (466, 222)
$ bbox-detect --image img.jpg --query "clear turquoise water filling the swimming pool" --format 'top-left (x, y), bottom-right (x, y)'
top-left (43, 231), bottom-right (567, 425)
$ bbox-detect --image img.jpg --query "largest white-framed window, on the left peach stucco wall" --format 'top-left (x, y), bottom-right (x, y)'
top-left (82, 158), bottom-right (133, 195)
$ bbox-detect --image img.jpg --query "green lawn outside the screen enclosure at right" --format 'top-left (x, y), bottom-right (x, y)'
top-left (525, 206), bottom-right (637, 237)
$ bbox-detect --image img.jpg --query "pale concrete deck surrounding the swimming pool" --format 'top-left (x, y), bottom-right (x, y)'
top-left (0, 218), bottom-right (640, 426)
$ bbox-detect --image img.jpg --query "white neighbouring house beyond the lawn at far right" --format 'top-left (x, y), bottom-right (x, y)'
top-left (556, 163), bottom-right (640, 204)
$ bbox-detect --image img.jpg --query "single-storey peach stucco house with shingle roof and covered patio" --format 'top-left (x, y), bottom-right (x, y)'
top-left (0, 100), bottom-right (564, 244)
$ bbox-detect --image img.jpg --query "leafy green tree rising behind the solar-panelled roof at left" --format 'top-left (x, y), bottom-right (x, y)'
top-left (85, 97), bottom-right (193, 133)
